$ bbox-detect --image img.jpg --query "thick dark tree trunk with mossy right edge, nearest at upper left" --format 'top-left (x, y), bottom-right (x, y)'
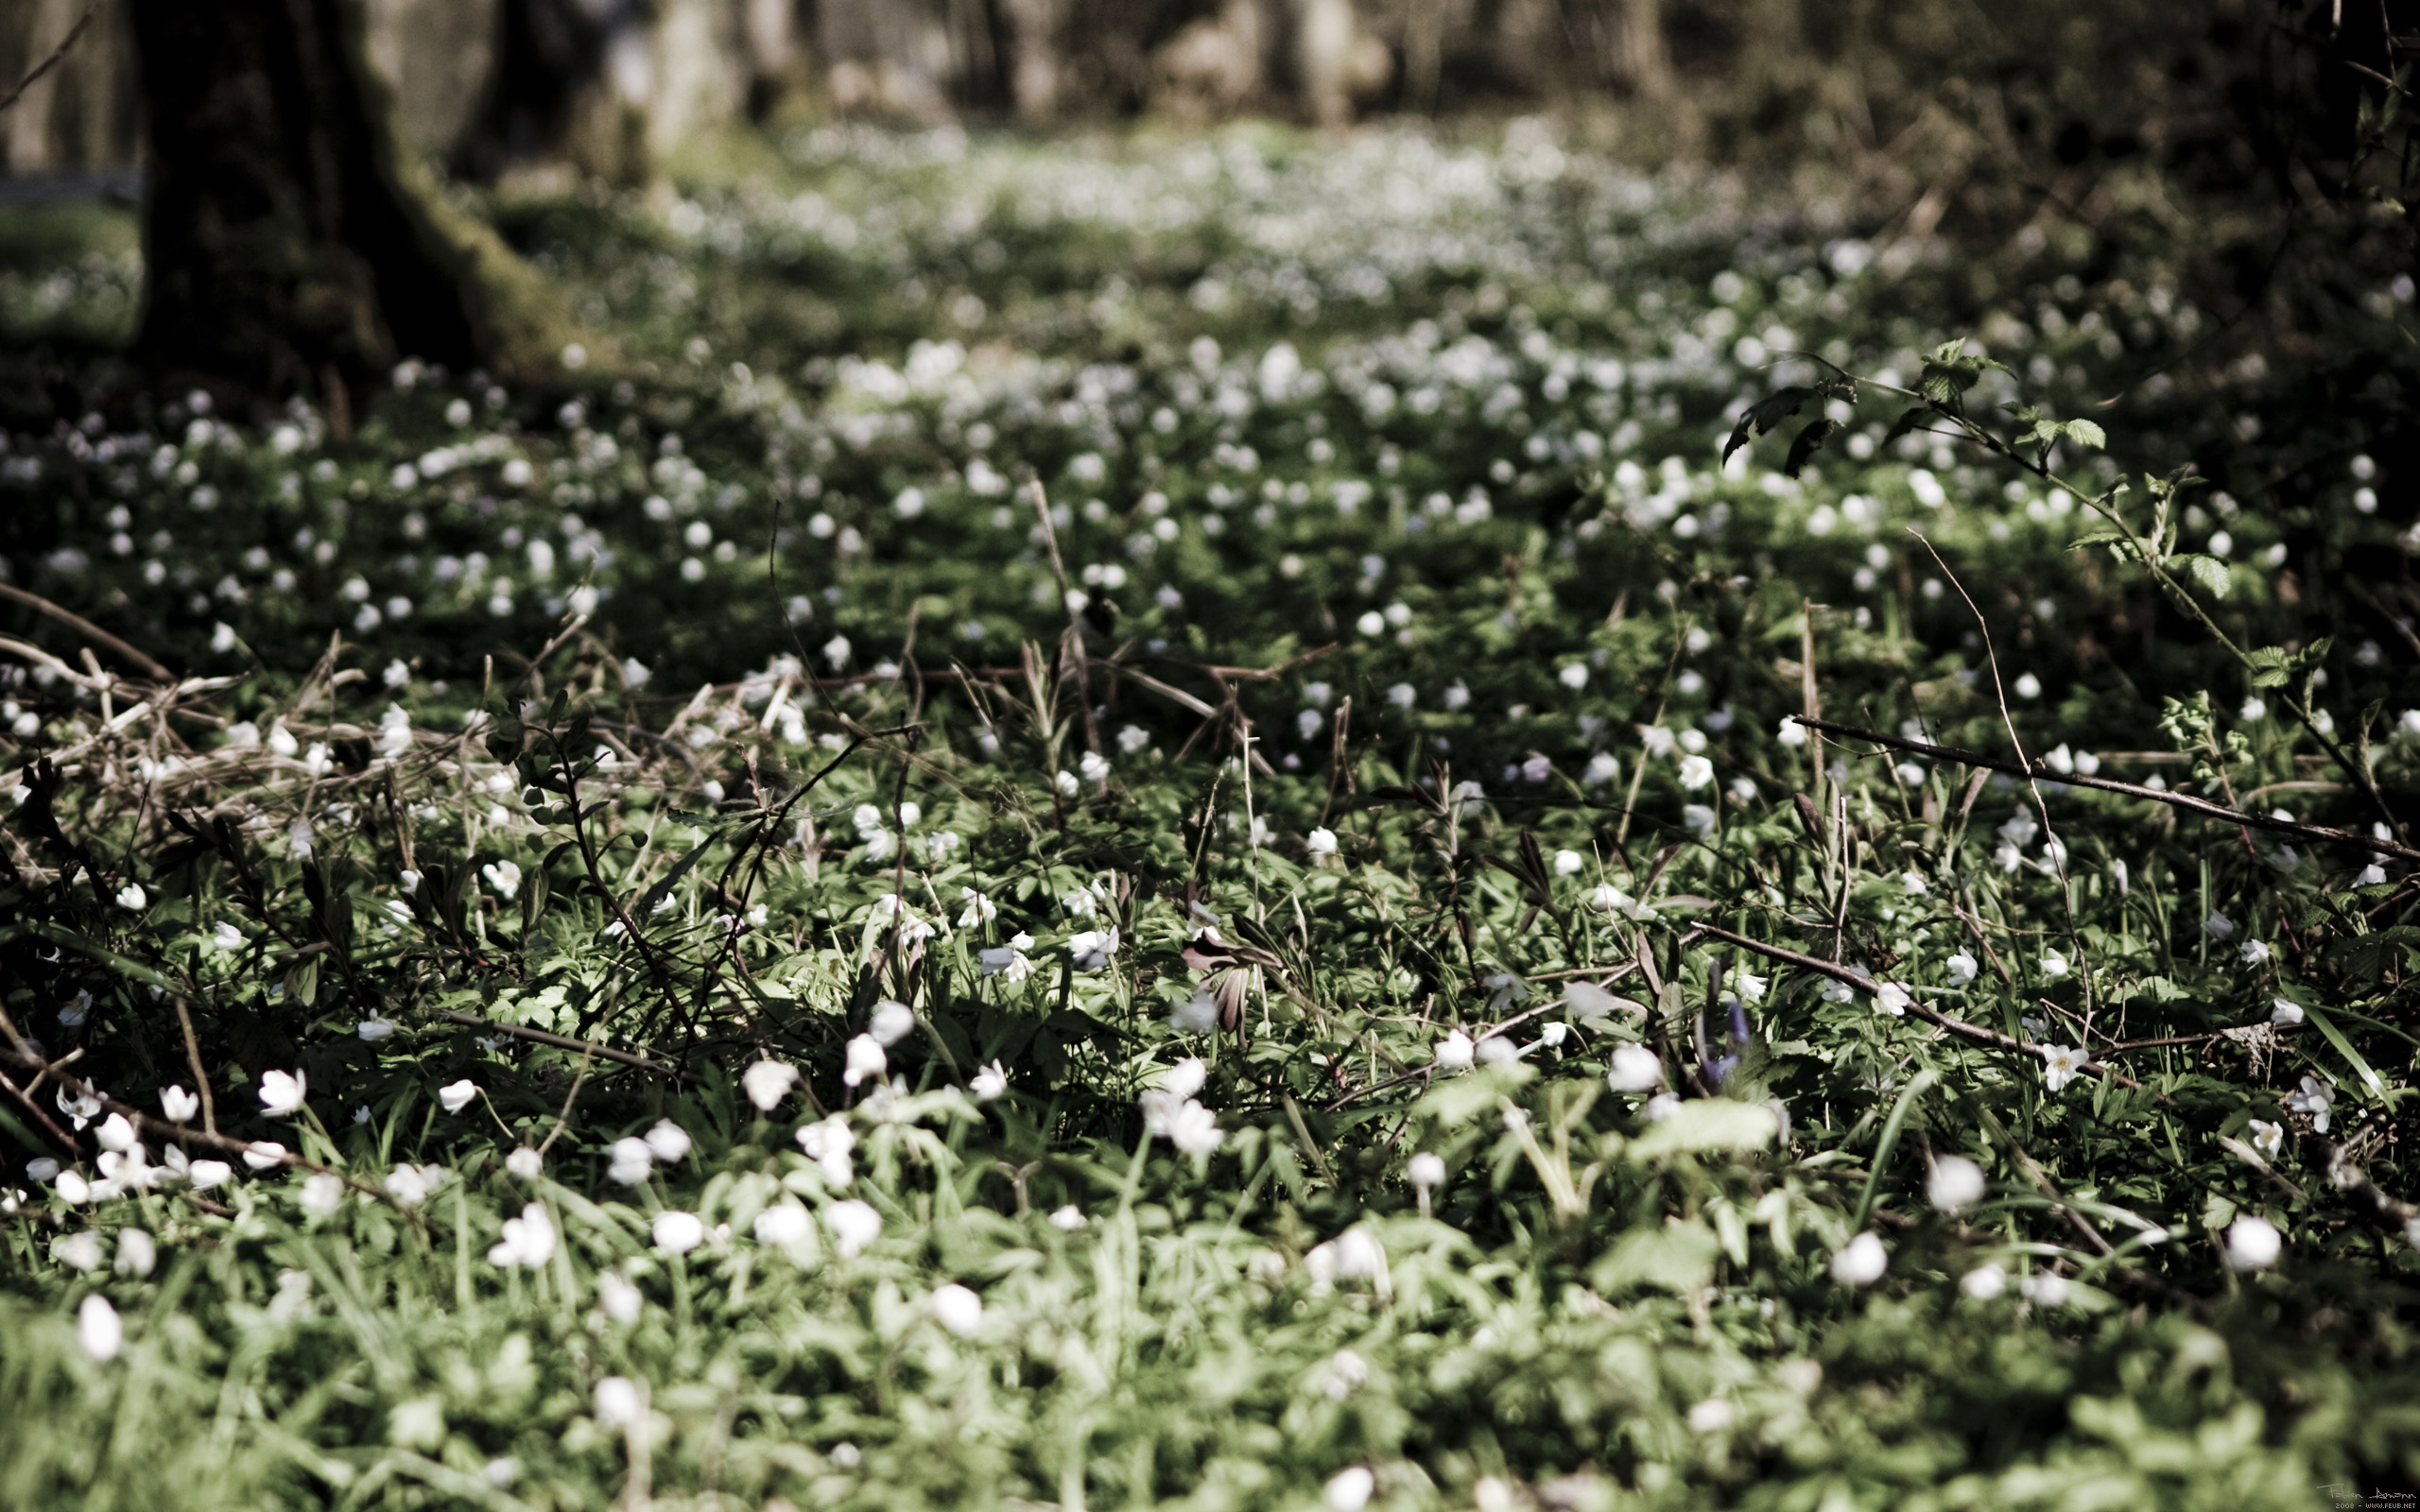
top-left (130, 0), bottom-right (569, 406)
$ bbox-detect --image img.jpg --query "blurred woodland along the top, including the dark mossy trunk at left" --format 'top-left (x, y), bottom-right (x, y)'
top-left (0, 0), bottom-right (2420, 425)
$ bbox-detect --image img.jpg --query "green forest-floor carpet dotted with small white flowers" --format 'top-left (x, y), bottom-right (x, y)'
top-left (0, 126), bottom-right (2420, 1512)
